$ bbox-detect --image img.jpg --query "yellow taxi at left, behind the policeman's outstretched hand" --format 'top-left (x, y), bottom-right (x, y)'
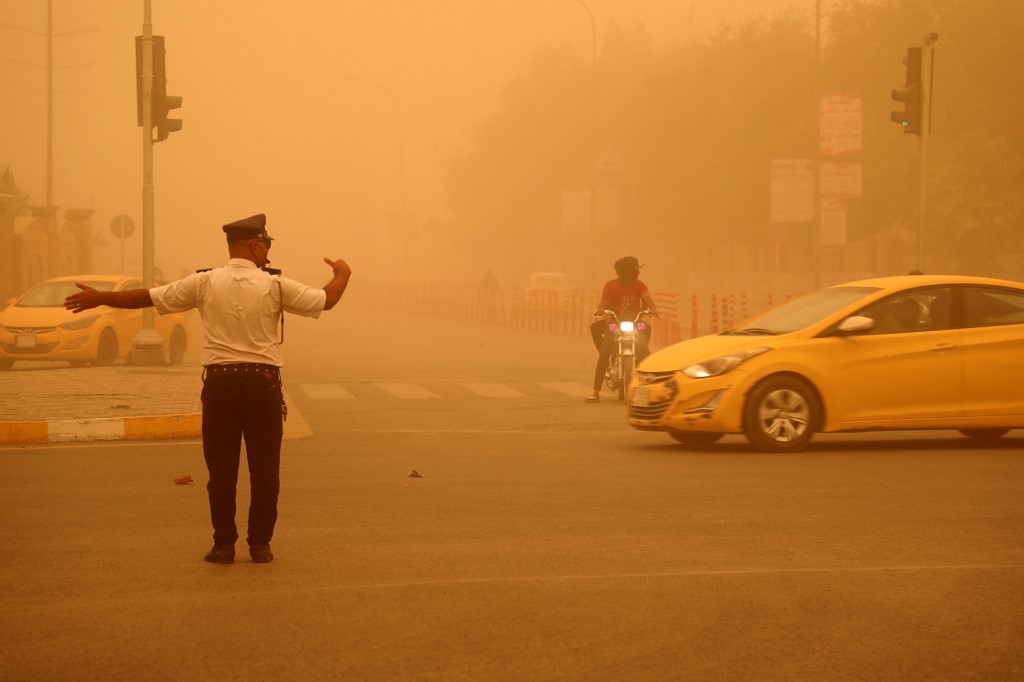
top-left (0, 274), bottom-right (188, 370)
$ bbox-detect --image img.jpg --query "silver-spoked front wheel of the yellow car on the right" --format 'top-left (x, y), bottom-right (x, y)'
top-left (743, 377), bottom-right (821, 453)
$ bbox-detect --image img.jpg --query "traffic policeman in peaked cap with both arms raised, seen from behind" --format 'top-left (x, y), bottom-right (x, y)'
top-left (65, 214), bottom-right (351, 563)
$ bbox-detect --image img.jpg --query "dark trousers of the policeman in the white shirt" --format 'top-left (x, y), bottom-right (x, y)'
top-left (203, 364), bottom-right (284, 545)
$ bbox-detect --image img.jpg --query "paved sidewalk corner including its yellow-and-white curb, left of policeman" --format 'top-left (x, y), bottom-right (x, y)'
top-left (0, 363), bottom-right (203, 444)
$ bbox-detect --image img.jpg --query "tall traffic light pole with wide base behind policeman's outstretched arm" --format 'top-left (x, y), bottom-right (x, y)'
top-left (128, 0), bottom-right (166, 365)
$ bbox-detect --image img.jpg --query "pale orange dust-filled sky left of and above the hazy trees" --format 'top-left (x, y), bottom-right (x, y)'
top-left (0, 0), bottom-right (794, 274)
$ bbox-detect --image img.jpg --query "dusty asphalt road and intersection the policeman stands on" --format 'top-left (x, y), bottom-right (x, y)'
top-left (0, 309), bottom-right (1024, 680)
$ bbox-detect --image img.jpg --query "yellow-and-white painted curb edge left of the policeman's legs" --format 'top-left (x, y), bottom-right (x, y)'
top-left (0, 414), bottom-right (203, 444)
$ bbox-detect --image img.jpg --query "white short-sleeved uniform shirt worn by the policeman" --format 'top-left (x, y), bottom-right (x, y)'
top-left (150, 258), bottom-right (327, 367)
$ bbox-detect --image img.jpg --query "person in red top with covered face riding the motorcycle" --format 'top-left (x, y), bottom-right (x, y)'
top-left (587, 256), bottom-right (659, 402)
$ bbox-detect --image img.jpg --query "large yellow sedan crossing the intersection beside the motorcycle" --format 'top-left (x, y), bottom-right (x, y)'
top-left (628, 275), bottom-right (1024, 452)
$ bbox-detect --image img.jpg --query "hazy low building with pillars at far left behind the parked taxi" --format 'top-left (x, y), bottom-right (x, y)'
top-left (0, 162), bottom-right (93, 309)
